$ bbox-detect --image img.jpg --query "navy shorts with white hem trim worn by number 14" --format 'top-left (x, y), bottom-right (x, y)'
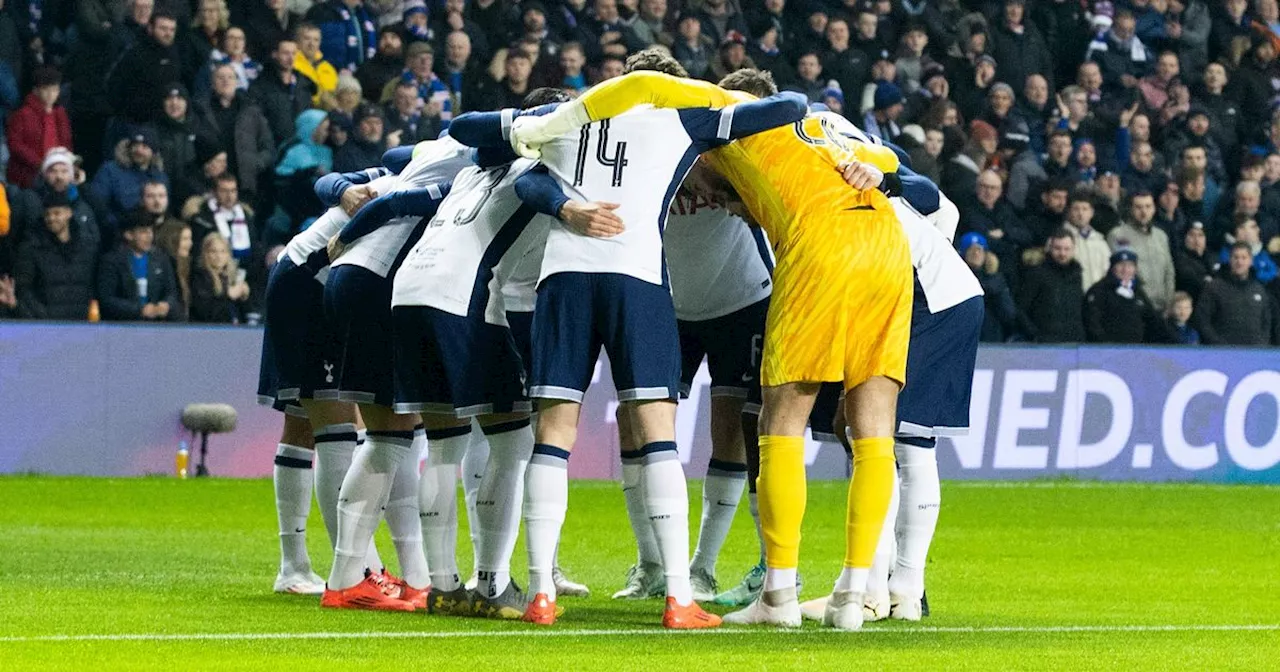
top-left (530, 273), bottom-right (680, 403)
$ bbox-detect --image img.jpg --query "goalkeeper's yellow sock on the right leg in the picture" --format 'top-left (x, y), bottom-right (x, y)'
top-left (844, 436), bottom-right (893, 568)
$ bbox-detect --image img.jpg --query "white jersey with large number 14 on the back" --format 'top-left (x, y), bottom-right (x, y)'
top-left (541, 106), bottom-right (733, 285)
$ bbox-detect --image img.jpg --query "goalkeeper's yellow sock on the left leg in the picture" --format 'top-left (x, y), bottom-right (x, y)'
top-left (755, 435), bottom-right (803, 570)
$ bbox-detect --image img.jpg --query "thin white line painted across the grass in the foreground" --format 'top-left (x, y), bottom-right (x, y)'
top-left (0, 623), bottom-right (1280, 644)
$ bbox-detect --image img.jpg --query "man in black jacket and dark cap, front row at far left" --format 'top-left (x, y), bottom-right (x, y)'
top-left (13, 192), bottom-right (97, 321)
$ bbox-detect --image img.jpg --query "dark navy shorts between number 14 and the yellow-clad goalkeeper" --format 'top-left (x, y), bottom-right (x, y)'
top-left (677, 298), bottom-right (769, 399)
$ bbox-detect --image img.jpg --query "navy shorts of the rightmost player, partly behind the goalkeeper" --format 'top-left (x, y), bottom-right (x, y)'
top-left (809, 297), bottom-right (984, 442)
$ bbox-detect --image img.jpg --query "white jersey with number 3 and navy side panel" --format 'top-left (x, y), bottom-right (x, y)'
top-left (392, 159), bottom-right (545, 325)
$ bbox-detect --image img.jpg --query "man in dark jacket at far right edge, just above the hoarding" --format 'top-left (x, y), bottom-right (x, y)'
top-left (1196, 242), bottom-right (1280, 346)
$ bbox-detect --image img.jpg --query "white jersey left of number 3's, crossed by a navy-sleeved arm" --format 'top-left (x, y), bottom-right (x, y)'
top-left (333, 137), bottom-right (474, 278)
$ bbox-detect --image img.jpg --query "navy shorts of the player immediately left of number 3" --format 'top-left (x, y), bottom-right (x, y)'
top-left (324, 265), bottom-right (396, 408)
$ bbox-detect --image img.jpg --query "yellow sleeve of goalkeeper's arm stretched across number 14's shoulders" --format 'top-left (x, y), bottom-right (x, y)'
top-left (579, 70), bottom-right (755, 122)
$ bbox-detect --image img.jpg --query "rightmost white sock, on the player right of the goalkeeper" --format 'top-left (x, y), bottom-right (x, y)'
top-left (888, 443), bottom-right (942, 599)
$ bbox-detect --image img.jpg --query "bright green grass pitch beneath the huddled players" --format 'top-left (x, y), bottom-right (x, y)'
top-left (0, 476), bottom-right (1280, 672)
